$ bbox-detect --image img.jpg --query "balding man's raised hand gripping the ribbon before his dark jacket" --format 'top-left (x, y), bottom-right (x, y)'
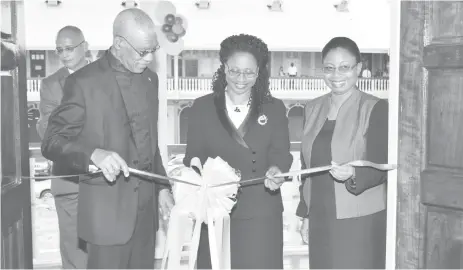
top-left (90, 148), bottom-right (129, 182)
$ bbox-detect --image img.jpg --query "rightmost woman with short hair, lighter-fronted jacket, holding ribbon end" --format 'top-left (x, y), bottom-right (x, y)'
top-left (297, 37), bottom-right (388, 269)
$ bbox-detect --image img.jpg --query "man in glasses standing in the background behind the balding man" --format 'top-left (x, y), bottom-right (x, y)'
top-left (37, 26), bottom-right (88, 269)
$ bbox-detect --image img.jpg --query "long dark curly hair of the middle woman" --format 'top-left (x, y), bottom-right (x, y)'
top-left (212, 34), bottom-right (272, 111)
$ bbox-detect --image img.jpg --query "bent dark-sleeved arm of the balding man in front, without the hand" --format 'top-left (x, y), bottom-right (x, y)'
top-left (42, 76), bottom-right (96, 173)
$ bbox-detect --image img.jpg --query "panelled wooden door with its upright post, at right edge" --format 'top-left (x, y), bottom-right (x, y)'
top-left (396, 1), bottom-right (463, 269)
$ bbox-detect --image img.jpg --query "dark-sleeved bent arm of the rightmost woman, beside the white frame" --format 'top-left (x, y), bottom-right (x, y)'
top-left (345, 100), bottom-right (388, 195)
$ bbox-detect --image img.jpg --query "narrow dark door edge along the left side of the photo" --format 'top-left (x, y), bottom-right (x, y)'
top-left (0, 1), bottom-right (32, 269)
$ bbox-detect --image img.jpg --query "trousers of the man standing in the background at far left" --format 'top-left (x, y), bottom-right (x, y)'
top-left (54, 193), bottom-right (87, 269)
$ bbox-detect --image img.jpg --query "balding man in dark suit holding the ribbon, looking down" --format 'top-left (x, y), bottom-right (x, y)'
top-left (42, 9), bottom-right (173, 269)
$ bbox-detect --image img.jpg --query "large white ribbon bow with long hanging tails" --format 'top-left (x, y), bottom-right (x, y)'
top-left (161, 157), bottom-right (240, 269)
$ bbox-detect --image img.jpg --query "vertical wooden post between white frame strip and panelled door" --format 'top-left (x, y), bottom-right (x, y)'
top-left (391, 1), bottom-right (425, 269)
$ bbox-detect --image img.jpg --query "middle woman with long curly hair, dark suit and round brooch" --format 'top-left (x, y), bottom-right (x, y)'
top-left (184, 34), bottom-right (292, 269)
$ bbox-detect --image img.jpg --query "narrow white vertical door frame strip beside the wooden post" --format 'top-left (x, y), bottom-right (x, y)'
top-left (386, 0), bottom-right (401, 269)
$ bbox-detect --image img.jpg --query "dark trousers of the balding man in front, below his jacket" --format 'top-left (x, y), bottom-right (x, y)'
top-left (87, 181), bottom-right (157, 269)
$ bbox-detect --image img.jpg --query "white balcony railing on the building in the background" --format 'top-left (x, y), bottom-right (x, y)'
top-left (27, 77), bottom-right (389, 101)
